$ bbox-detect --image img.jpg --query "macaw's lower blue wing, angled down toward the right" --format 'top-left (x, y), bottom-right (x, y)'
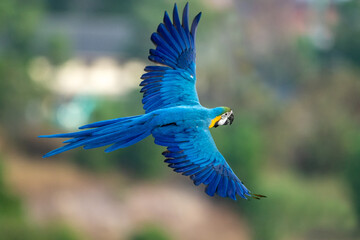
top-left (152, 125), bottom-right (252, 200)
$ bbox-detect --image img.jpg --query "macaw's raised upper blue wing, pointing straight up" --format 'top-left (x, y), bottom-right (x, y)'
top-left (140, 4), bottom-right (201, 113)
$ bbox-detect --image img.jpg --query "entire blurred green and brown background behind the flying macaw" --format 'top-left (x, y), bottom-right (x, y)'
top-left (0, 0), bottom-right (360, 240)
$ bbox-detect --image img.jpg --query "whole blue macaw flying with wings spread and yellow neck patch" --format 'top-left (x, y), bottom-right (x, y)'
top-left (39, 4), bottom-right (264, 200)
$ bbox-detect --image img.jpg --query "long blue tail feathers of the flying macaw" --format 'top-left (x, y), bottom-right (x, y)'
top-left (39, 114), bottom-right (152, 158)
